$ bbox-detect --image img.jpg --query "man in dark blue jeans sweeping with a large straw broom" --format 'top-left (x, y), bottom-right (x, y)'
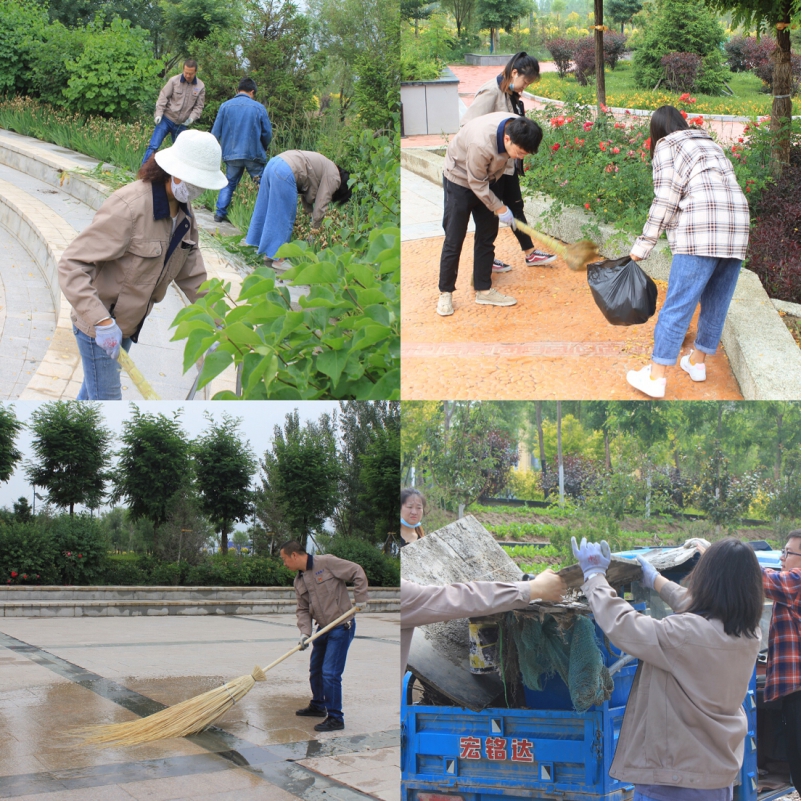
top-left (279, 541), bottom-right (368, 732)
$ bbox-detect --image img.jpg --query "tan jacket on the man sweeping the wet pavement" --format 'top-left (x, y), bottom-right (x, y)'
top-left (293, 554), bottom-right (368, 637)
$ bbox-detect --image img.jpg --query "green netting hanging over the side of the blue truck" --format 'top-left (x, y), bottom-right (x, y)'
top-left (505, 613), bottom-right (613, 712)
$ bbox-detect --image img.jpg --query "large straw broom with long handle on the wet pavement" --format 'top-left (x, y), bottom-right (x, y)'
top-left (73, 606), bottom-right (359, 747)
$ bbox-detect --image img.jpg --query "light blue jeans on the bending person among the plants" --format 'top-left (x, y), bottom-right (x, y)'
top-left (245, 156), bottom-right (298, 259)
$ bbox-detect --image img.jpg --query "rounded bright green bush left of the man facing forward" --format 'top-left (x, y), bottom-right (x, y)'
top-left (64, 17), bottom-right (162, 118)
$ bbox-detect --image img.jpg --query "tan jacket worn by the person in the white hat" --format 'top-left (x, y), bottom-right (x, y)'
top-left (58, 181), bottom-right (206, 339)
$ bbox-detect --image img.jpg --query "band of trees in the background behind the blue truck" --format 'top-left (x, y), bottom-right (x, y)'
top-left (402, 401), bottom-right (800, 525)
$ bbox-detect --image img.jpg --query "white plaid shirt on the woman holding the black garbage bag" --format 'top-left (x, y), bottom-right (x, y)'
top-left (631, 128), bottom-right (749, 259)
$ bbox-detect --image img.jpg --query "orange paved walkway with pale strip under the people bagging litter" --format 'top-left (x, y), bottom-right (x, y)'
top-left (401, 170), bottom-right (742, 400)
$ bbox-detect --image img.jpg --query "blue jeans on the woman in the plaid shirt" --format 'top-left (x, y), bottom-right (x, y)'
top-left (652, 253), bottom-right (741, 364)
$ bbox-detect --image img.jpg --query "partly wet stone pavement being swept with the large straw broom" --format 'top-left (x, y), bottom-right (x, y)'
top-left (0, 613), bottom-right (400, 801)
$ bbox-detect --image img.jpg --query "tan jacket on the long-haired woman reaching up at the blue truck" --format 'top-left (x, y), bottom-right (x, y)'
top-left (582, 574), bottom-right (760, 790)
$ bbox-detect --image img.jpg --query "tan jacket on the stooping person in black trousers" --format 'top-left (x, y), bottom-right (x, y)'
top-left (443, 112), bottom-right (517, 212)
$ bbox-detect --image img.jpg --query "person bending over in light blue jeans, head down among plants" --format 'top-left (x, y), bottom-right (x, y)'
top-left (245, 150), bottom-right (351, 266)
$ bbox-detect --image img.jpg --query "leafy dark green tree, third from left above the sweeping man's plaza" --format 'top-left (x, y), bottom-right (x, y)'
top-left (112, 406), bottom-right (192, 528)
